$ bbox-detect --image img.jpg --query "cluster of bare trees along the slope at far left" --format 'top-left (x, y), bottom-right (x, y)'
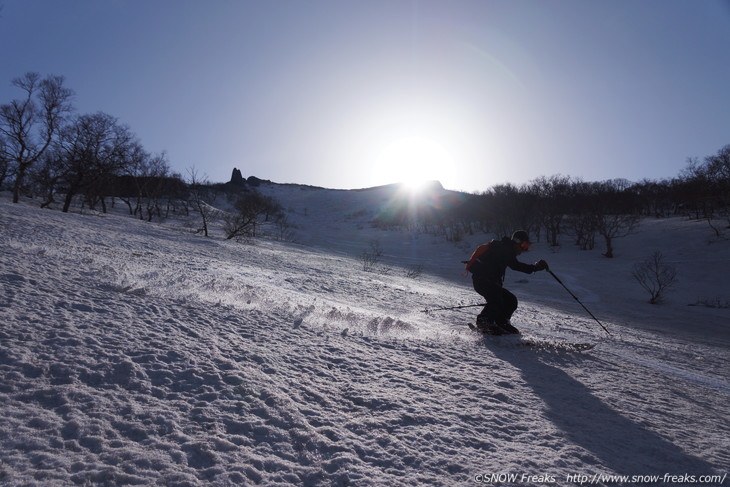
top-left (0, 72), bottom-right (283, 238)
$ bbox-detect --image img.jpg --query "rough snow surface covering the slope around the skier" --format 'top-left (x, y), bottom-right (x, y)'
top-left (0, 185), bottom-right (730, 486)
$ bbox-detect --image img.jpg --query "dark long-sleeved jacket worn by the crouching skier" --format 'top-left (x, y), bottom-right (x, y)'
top-left (466, 237), bottom-right (537, 286)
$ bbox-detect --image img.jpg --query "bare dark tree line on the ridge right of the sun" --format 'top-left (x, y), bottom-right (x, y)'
top-left (374, 145), bottom-right (730, 257)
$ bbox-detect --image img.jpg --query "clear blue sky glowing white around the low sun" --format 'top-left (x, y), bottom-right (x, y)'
top-left (0, 0), bottom-right (730, 191)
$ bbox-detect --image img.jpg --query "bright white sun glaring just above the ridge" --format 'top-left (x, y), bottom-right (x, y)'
top-left (373, 135), bottom-right (454, 191)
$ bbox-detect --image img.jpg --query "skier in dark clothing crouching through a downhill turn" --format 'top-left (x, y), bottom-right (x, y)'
top-left (466, 230), bottom-right (548, 335)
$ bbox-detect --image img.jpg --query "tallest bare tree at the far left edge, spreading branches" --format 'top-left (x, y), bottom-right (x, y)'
top-left (0, 72), bottom-right (73, 203)
